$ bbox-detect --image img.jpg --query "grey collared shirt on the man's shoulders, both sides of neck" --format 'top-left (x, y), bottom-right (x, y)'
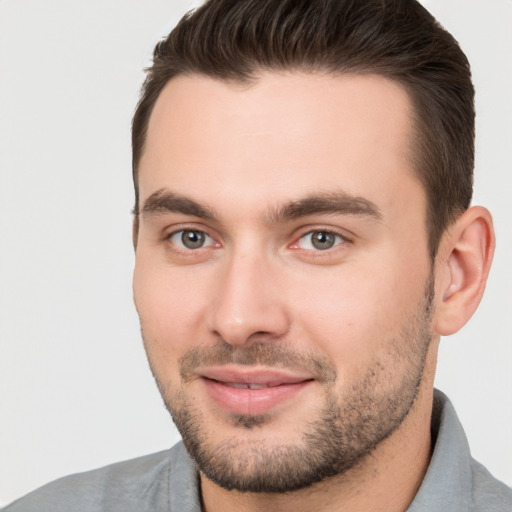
top-left (4, 391), bottom-right (512, 512)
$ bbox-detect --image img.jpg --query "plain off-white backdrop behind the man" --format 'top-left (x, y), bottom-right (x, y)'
top-left (0, 0), bottom-right (512, 504)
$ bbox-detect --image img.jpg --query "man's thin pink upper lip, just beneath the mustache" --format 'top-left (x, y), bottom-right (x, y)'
top-left (197, 366), bottom-right (313, 386)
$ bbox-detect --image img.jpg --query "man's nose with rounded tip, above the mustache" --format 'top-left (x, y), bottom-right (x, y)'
top-left (209, 250), bottom-right (290, 345)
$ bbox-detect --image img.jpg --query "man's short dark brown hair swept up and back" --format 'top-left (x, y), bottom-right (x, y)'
top-left (132, 0), bottom-right (475, 258)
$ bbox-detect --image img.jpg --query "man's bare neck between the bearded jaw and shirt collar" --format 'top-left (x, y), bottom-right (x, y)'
top-left (201, 379), bottom-right (433, 512)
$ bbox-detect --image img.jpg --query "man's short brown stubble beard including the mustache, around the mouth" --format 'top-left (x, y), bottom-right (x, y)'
top-left (144, 276), bottom-right (434, 493)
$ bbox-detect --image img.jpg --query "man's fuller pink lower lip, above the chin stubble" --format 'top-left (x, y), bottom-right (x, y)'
top-left (203, 378), bottom-right (313, 416)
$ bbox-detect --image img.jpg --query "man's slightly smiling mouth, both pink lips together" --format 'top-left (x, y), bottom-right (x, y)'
top-left (199, 367), bottom-right (314, 416)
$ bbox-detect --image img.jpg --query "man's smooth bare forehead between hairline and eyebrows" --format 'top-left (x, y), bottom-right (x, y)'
top-left (139, 72), bottom-right (423, 222)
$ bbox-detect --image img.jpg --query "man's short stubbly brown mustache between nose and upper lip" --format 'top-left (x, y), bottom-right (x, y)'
top-left (178, 340), bottom-right (337, 384)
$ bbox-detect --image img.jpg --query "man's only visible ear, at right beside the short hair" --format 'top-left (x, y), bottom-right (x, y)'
top-left (434, 206), bottom-right (495, 336)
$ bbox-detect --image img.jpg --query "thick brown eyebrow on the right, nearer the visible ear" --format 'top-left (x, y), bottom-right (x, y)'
top-left (270, 192), bottom-right (382, 223)
